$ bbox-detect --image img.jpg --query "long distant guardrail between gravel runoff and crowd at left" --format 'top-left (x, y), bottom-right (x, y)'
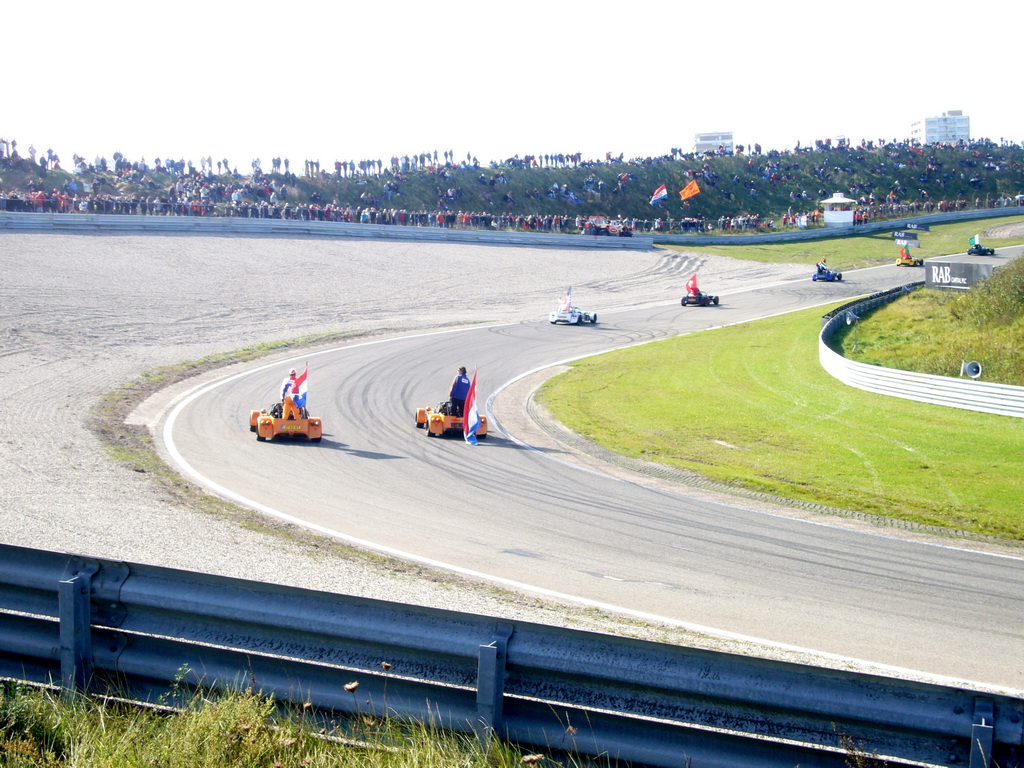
top-left (0, 211), bottom-right (654, 250)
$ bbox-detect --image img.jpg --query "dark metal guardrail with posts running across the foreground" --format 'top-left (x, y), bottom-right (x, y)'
top-left (0, 545), bottom-right (1024, 768)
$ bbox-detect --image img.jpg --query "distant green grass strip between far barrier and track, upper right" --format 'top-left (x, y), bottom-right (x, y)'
top-left (663, 216), bottom-right (1024, 272)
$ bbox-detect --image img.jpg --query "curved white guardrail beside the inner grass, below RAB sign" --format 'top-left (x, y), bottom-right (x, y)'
top-left (818, 283), bottom-right (1024, 419)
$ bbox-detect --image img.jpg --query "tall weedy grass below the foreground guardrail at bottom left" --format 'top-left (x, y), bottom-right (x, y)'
top-left (0, 683), bottom-right (573, 768)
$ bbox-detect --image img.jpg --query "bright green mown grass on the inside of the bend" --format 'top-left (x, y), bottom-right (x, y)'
top-left (539, 301), bottom-right (1024, 542)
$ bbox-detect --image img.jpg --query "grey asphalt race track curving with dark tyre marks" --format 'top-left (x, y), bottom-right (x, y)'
top-left (165, 249), bottom-right (1024, 687)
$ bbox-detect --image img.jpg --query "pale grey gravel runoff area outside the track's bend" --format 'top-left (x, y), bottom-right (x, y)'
top-left (0, 228), bottom-right (1007, 679)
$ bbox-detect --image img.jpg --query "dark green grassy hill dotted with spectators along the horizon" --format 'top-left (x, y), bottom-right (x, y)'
top-left (0, 140), bottom-right (1024, 225)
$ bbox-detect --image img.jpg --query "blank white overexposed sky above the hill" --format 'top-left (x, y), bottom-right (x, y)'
top-left (0, 0), bottom-right (1024, 172)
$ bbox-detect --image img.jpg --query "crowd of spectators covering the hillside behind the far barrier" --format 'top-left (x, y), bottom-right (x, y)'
top-left (0, 139), bottom-right (1024, 232)
